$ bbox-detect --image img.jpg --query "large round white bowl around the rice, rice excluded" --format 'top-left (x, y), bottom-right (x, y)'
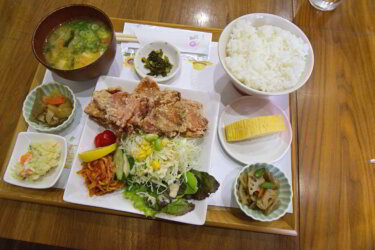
top-left (218, 13), bottom-right (314, 95)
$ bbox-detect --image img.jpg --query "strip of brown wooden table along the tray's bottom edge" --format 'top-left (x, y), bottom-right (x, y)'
top-left (0, 197), bottom-right (298, 250)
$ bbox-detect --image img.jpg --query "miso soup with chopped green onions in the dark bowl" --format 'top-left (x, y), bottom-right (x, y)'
top-left (43, 19), bottom-right (111, 70)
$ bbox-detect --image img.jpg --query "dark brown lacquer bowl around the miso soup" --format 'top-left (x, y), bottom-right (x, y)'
top-left (32, 4), bottom-right (116, 81)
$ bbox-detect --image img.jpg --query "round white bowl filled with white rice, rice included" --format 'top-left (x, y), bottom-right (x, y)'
top-left (218, 13), bottom-right (314, 95)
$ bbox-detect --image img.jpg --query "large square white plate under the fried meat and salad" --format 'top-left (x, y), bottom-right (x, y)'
top-left (64, 76), bottom-right (220, 225)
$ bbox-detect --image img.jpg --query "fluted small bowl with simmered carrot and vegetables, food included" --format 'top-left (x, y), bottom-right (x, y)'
top-left (23, 83), bottom-right (77, 132)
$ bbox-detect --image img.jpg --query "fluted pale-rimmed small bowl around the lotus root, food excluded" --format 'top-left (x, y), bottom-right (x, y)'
top-left (234, 163), bottom-right (293, 221)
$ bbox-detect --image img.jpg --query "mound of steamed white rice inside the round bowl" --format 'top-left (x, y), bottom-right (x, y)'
top-left (225, 20), bottom-right (309, 92)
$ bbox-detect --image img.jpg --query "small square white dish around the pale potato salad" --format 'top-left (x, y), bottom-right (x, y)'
top-left (4, 132), bottom-right (68, 189)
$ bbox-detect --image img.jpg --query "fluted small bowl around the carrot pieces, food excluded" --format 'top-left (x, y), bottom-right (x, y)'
top-left (22, 83), bottom-right (77, 132)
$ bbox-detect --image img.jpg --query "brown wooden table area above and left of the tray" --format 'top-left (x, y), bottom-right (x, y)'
top-left (0, 0), bottom-right (292, 171)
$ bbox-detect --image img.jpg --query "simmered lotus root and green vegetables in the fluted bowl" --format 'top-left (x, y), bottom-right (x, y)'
top-left (239, 168), bottom-right (280, 215)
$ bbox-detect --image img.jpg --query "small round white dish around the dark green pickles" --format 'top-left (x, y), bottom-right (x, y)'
top-left (134, 41), bottom-right (181, 82)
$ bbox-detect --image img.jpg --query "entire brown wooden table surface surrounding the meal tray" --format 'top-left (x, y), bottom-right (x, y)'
top-left (0, 0), bottom-right (375, 249)
